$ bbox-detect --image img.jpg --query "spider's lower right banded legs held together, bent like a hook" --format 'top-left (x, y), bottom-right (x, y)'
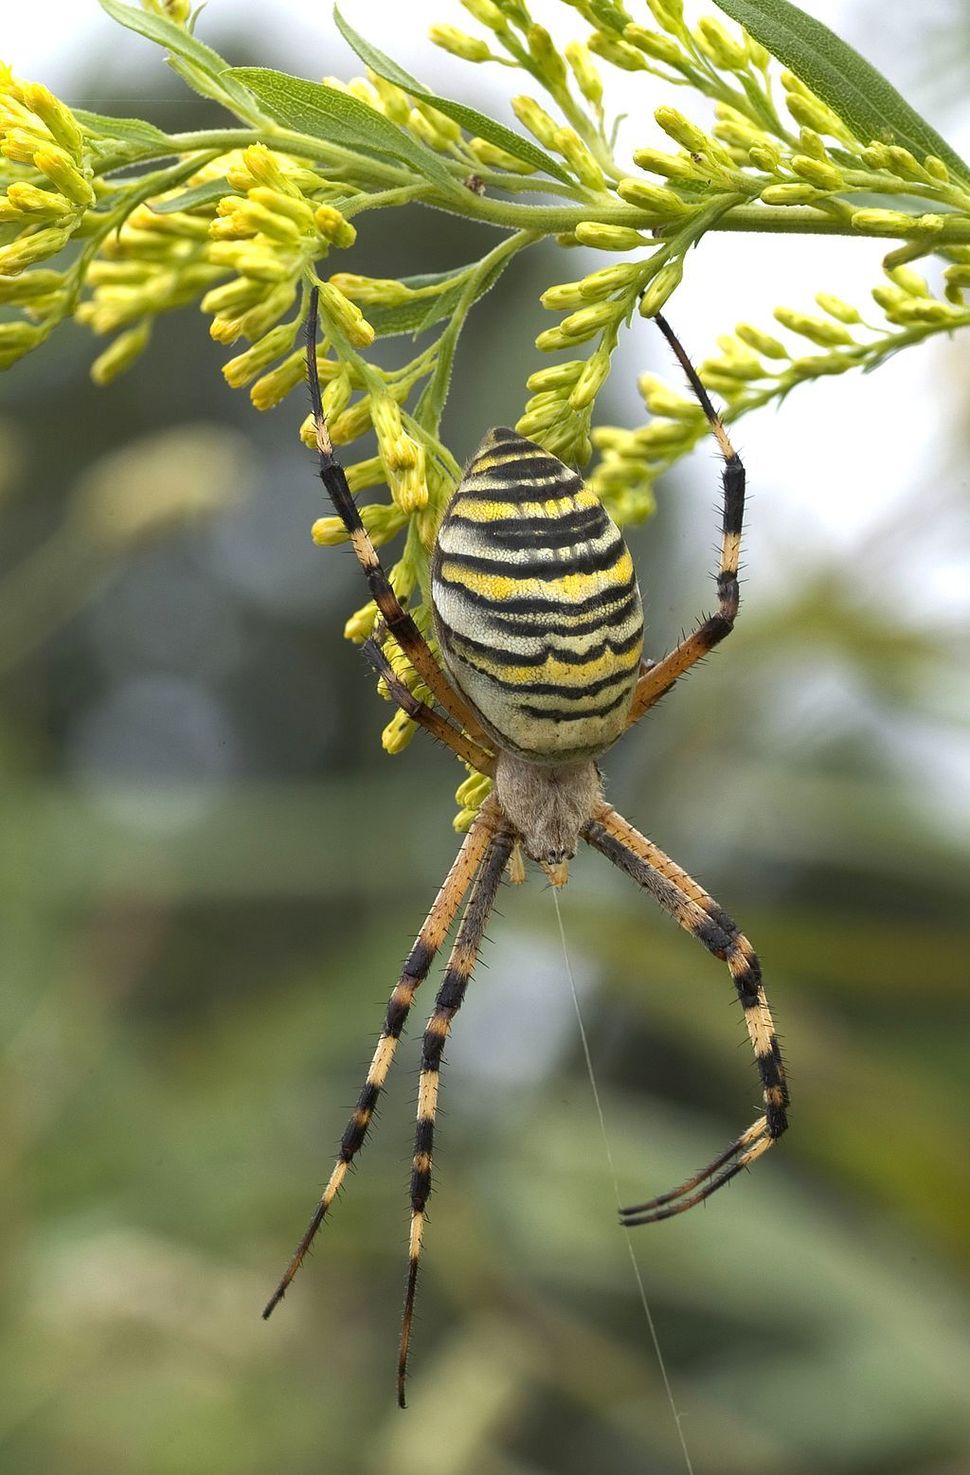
top-left (582, 804), bottom-right (789, 1227)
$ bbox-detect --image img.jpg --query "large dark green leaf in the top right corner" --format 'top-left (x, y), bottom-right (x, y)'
top-left (716, 0), bottom-right (970, 181)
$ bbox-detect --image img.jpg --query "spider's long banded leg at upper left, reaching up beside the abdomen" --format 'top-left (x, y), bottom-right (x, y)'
top-left (307, 288), bottom-right (485, 739)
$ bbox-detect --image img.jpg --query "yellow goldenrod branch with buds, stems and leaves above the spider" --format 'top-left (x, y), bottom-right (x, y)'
top-left (0, 0), bottom-right (970, 817)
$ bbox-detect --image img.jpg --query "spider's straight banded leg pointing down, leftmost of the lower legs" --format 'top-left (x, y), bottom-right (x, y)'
top-left (262, 799), bottom-right (497, 1319)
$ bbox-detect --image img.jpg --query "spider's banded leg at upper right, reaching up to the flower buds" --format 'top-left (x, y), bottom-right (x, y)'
top-left (627, 313), bottom-right (744, 727)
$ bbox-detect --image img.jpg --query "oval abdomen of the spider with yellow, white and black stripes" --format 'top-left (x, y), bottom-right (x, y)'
top-left (432, 429), bottom-right (643, 763)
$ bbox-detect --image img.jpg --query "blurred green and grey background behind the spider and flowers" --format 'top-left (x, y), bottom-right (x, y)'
top-left (0, 4), bottom-right (970, 1475)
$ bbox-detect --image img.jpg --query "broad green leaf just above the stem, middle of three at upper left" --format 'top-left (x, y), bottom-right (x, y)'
top-left (222, 66), bottom-right (461, 195)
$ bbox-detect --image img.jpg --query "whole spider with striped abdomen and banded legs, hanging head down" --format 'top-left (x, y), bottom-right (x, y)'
top-left (262, 291), bottom-right (789, 1407)
